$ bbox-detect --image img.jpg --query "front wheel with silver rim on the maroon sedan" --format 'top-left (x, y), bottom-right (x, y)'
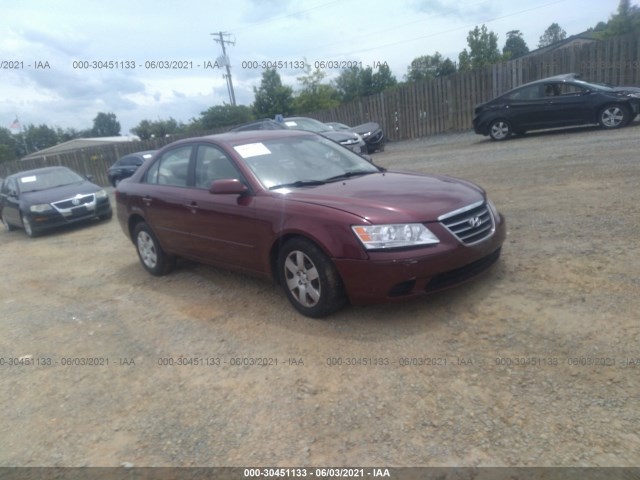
top-left (278, 238), bottom-right (347, 318)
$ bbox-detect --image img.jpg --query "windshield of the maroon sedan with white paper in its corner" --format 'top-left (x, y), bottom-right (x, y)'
top-left (234, 135), bottom-right (380, 190)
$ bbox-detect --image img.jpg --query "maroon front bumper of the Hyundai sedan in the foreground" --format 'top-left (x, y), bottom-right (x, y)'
top-left (334, 215), bottom-right (506, 305)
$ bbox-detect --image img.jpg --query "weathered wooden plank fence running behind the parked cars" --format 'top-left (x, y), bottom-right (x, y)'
top-left (0, 33), bottom-right (640, 185)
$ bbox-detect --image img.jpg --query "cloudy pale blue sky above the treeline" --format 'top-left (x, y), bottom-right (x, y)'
top-left (0, 0), bottom-right (624, 134)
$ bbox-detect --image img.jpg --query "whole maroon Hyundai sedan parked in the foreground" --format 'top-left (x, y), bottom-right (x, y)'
top-left (116, 130), bottom-right (505, 317)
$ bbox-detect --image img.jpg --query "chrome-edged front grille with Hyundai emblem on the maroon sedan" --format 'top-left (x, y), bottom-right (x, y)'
top-left (438, 201), bottom-right (495, 245)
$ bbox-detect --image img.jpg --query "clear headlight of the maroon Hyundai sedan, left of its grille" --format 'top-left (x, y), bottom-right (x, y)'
top-left (351, 223), bottom-right (440, 250)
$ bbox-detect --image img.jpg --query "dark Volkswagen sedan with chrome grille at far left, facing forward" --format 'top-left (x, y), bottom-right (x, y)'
top-left (0, 167), bottom-right (112, 237)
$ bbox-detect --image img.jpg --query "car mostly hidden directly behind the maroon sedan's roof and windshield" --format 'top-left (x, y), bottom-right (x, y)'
top-left (229, 117), bottom-right (367, 153)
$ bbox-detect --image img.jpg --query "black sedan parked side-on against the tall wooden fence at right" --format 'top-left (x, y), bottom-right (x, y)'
top-left (473, 73), bottom-right (640, 140)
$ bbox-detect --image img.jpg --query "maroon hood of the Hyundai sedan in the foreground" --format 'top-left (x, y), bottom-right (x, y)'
top-left (284, 172), bottom-right (484, 223)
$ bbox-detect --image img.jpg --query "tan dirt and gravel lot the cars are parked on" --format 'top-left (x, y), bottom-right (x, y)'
top-left (0, 121), bottom-right (640, 466)
